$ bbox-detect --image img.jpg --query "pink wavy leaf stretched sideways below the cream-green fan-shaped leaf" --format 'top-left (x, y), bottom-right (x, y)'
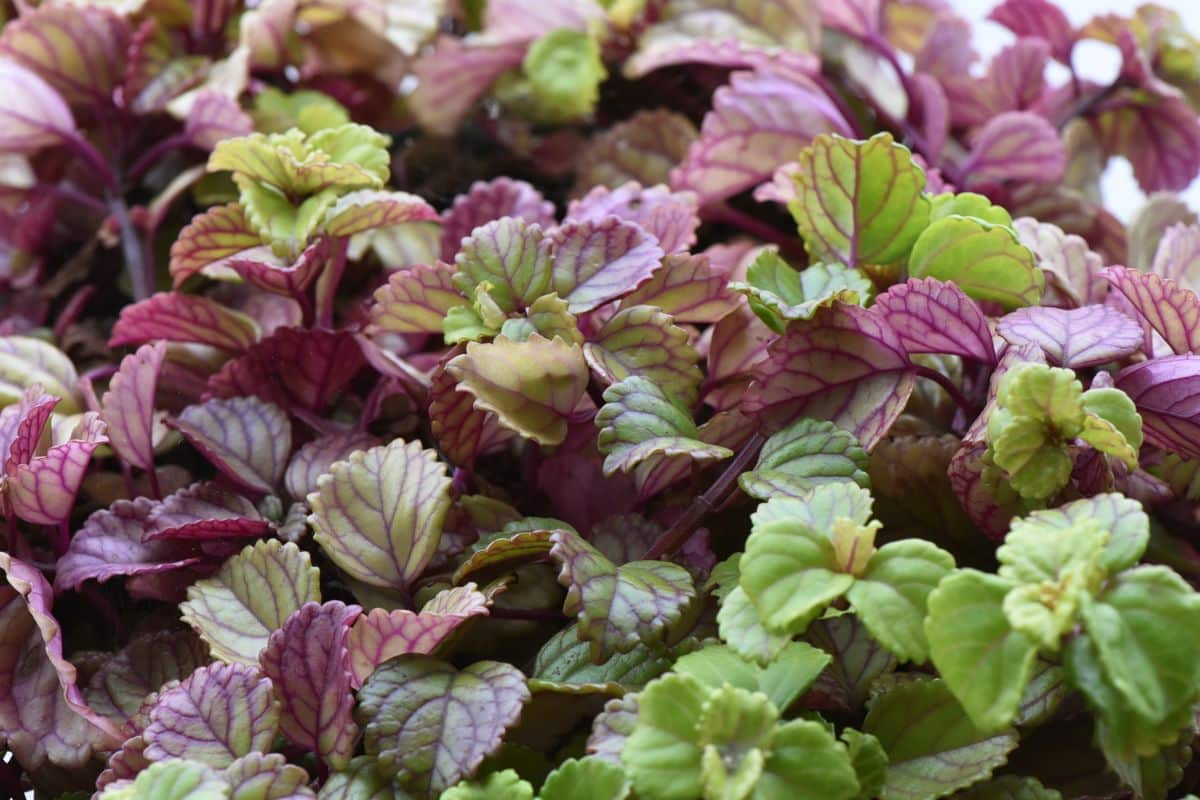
top-left (347, 583), bottom-right (488, 688)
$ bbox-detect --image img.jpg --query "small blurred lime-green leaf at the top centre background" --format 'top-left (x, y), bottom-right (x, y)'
top-left (522, 29), bottom-right (608, 121)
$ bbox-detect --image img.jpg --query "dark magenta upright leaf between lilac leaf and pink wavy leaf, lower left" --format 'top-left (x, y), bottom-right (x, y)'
top-left (259, 601), bottom-right (362, 769)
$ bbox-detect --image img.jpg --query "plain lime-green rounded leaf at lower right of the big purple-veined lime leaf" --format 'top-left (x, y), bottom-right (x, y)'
top-left (908, 215), bottom-right (1045, 311)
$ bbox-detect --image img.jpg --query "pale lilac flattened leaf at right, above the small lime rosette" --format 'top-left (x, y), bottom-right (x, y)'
top-left (997, 306), bottom-right (1142, 369)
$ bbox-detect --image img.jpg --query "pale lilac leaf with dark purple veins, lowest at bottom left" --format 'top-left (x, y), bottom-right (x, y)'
top-left (143, 663), bottom-right (280, 769)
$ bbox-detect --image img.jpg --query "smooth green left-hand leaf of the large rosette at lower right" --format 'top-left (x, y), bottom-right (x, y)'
top-left (925, 570), bottom-right (1037, 730)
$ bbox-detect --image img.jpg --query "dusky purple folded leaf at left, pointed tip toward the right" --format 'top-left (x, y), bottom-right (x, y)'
top-left (54, 498), bottom-right (202, 593)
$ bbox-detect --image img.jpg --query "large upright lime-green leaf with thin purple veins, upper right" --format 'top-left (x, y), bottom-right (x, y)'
top-left (787, 133), bottom-right (930, 266)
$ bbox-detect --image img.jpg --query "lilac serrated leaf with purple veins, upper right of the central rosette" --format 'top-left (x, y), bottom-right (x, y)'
top-left (550, 217), bottom-right (662, 314)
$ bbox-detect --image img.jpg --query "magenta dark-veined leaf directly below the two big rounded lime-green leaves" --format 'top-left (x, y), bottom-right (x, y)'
top-left (871, 278), bottom-right (996, 365)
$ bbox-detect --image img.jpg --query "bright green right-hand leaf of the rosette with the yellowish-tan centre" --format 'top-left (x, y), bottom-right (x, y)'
top-left (846, 539), bottom-right (954, 663)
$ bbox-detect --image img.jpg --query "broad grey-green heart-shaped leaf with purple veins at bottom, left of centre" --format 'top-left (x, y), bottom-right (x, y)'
top-left (356, 655), bottom-right (529, 794)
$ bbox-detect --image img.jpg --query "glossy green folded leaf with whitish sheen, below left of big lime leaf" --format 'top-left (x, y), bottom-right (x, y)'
top-left (730, 248), bottom-right (871, 333)
